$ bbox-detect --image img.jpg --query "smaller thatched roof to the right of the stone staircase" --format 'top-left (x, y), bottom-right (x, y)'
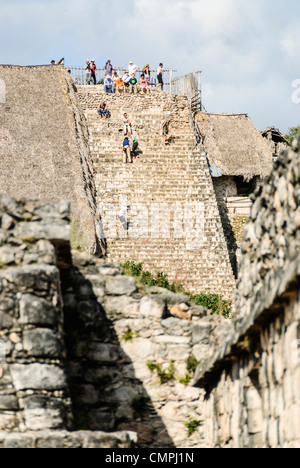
top-left (196, 112), bottom-right (273, 180)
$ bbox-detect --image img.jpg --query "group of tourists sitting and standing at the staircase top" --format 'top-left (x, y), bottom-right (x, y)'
top-left (85, 59), bottom-right (165, 93)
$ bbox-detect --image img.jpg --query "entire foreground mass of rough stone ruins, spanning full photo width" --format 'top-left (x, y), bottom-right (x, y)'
top-left (0, 133), bottom-right (300, 448)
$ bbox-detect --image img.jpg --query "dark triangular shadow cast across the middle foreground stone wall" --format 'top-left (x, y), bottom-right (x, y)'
top-left (62, 265), bottom-right (174, 448)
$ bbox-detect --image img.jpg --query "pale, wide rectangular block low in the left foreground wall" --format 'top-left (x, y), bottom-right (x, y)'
top-left (11, 363), bottom-right (66, 390)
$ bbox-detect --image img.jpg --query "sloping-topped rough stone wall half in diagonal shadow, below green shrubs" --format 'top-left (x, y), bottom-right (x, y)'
top-left (63, 252), bottom-right (232, 448)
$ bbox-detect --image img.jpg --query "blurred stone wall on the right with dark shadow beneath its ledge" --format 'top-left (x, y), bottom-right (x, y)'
top-left (195, 138), bottom-right (300, 448)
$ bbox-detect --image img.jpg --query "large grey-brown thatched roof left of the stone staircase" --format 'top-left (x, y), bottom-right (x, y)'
top-left (0, 65), bottom-right (99, 254)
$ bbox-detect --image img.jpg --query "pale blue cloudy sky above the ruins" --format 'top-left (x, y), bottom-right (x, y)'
top-left (0, 0), bottom-right (300, 132)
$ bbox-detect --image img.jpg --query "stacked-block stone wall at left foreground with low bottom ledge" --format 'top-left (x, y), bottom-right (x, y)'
top-left (0, 195), bottom-right (135, 448)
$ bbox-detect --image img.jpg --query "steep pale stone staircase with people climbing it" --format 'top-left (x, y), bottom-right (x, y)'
top-left (78, 86), bottom-right (235, 298)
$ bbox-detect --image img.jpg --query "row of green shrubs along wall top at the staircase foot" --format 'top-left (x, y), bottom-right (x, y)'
top-left (121, 260), bottom-right (232, 318)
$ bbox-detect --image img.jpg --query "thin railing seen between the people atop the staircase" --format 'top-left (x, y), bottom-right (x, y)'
top-left (65, 66), bottom-right (176, 94)
